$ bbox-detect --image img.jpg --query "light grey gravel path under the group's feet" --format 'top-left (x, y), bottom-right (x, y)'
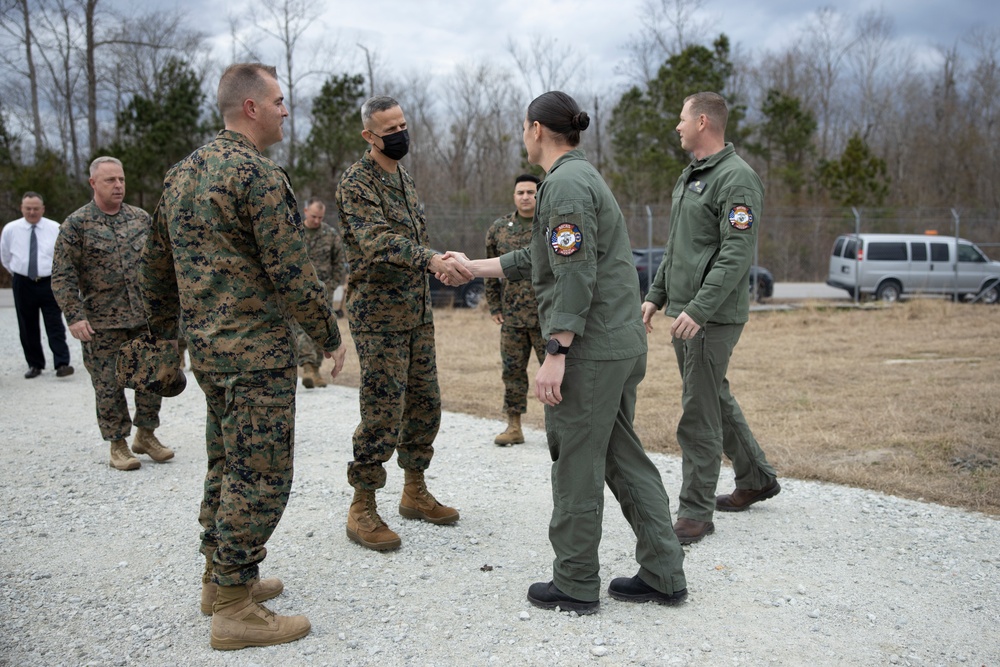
top-left (0, 294), bottom-right (1000, 667)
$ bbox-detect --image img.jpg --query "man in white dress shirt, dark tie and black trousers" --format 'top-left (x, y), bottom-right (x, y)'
top-left (0, 192), bottom-right (73, 380)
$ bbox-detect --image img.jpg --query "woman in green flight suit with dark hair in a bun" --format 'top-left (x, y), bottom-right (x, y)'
top-left (448, 91), bottom-right (687, 614)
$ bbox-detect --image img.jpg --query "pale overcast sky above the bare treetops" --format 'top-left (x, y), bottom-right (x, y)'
top-left (131, 0), bottom-right (1000, 96)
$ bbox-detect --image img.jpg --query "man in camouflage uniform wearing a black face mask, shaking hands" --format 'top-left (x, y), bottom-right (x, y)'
top-left (337, 96), bottom-right (472, 550)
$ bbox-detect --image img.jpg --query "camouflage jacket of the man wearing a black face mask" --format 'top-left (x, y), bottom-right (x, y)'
top-left (337, 153), bottom-right (434, 333)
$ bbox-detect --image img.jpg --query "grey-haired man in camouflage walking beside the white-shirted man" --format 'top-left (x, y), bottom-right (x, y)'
top-left (52, 157), bottom-right (174, 470)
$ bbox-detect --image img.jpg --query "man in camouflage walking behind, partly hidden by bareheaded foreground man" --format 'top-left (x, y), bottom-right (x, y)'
top-left (292, 197), bottom-right (347, 389)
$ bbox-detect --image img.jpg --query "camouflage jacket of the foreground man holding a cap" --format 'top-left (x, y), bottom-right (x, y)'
top-left (139, 130), bottom-right (340, 373)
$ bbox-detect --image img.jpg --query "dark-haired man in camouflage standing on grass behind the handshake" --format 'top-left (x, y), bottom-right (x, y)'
top-left (483, 174), bottom-right (545, 447)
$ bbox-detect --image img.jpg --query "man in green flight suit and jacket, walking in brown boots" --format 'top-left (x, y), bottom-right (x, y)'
top-left (642, 92), bottom-right (781, 544)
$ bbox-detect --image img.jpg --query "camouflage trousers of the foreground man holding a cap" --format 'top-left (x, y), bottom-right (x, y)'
top-left (194, 367), bottom-right (296, 586)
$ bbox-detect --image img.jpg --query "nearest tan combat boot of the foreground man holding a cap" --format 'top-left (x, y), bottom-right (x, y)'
top-left (211, 583), bottom-right (312, 651)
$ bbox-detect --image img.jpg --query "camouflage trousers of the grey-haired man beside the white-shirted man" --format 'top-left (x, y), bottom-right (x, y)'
top-left (82, 326), bottom-right (163, 442)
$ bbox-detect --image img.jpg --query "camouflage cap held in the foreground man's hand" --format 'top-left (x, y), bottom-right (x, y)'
top-left (115, 333), bottom-right (187, 398)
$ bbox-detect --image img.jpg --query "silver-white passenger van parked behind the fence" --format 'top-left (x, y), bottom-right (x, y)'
top-left (826, 234), bottom-right (1000, 303)
